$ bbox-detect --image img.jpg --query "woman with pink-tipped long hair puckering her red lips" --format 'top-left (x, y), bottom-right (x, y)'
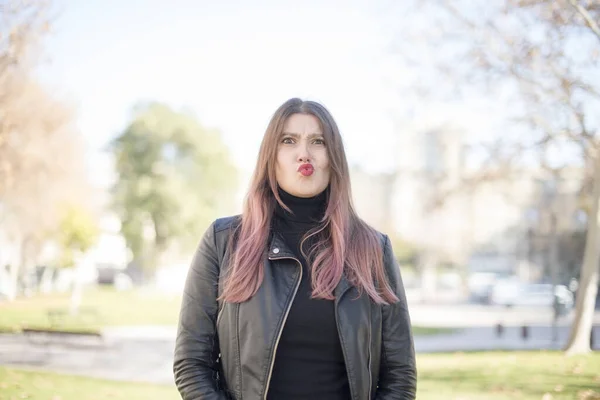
top-left (174, 99), bottom-right (416, 400)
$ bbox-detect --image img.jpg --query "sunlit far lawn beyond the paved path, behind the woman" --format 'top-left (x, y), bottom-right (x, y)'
top-left (0, 287), bottom-right (452, 335)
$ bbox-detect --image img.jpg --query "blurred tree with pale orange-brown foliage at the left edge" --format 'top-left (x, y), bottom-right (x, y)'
top-left (0, 1), bottom-right (87, 298)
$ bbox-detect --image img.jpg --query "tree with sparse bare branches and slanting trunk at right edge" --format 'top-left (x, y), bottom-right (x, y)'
top-left (394, 0), bottom-right (600, 354)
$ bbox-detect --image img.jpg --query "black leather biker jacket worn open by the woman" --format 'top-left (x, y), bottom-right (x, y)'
top-left (173, 217), bottom-right (416, 400)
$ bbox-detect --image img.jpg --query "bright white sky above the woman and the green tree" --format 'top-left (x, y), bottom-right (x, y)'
top-left (39, 0), bottom-right (412, 191)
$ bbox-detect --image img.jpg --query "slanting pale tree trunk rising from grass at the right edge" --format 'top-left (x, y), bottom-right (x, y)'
top-left (565, 158), bottom-right (600, 355)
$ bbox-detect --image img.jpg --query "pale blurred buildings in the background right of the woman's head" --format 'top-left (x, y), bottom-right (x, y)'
top-left (352, 121), bottom-right (582, 281)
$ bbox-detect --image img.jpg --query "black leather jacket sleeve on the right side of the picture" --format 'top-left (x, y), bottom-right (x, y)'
top-left (375, 236), bottom-right (417, 400)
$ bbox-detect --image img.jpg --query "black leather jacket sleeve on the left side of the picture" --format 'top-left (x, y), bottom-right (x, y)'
top-left (173, 223), bottom-right (227, 400)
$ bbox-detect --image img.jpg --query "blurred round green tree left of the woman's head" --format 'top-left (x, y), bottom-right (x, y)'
top-left (110, 103), bottom-right (236, 276)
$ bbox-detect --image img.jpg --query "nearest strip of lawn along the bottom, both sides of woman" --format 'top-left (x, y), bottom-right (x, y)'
top-left (0, 352), bottom-right (600, 400)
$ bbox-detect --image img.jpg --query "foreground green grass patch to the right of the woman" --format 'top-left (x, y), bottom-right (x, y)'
top-left (417, 352), bottom-right (600, 400)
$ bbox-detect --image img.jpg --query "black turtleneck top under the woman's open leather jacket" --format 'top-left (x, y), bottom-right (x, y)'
top-left (268, 189), bottom-right (350, 400)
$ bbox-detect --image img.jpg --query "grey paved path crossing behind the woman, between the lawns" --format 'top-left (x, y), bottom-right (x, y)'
top-left (0, 327), bottom-right (600, 384)
